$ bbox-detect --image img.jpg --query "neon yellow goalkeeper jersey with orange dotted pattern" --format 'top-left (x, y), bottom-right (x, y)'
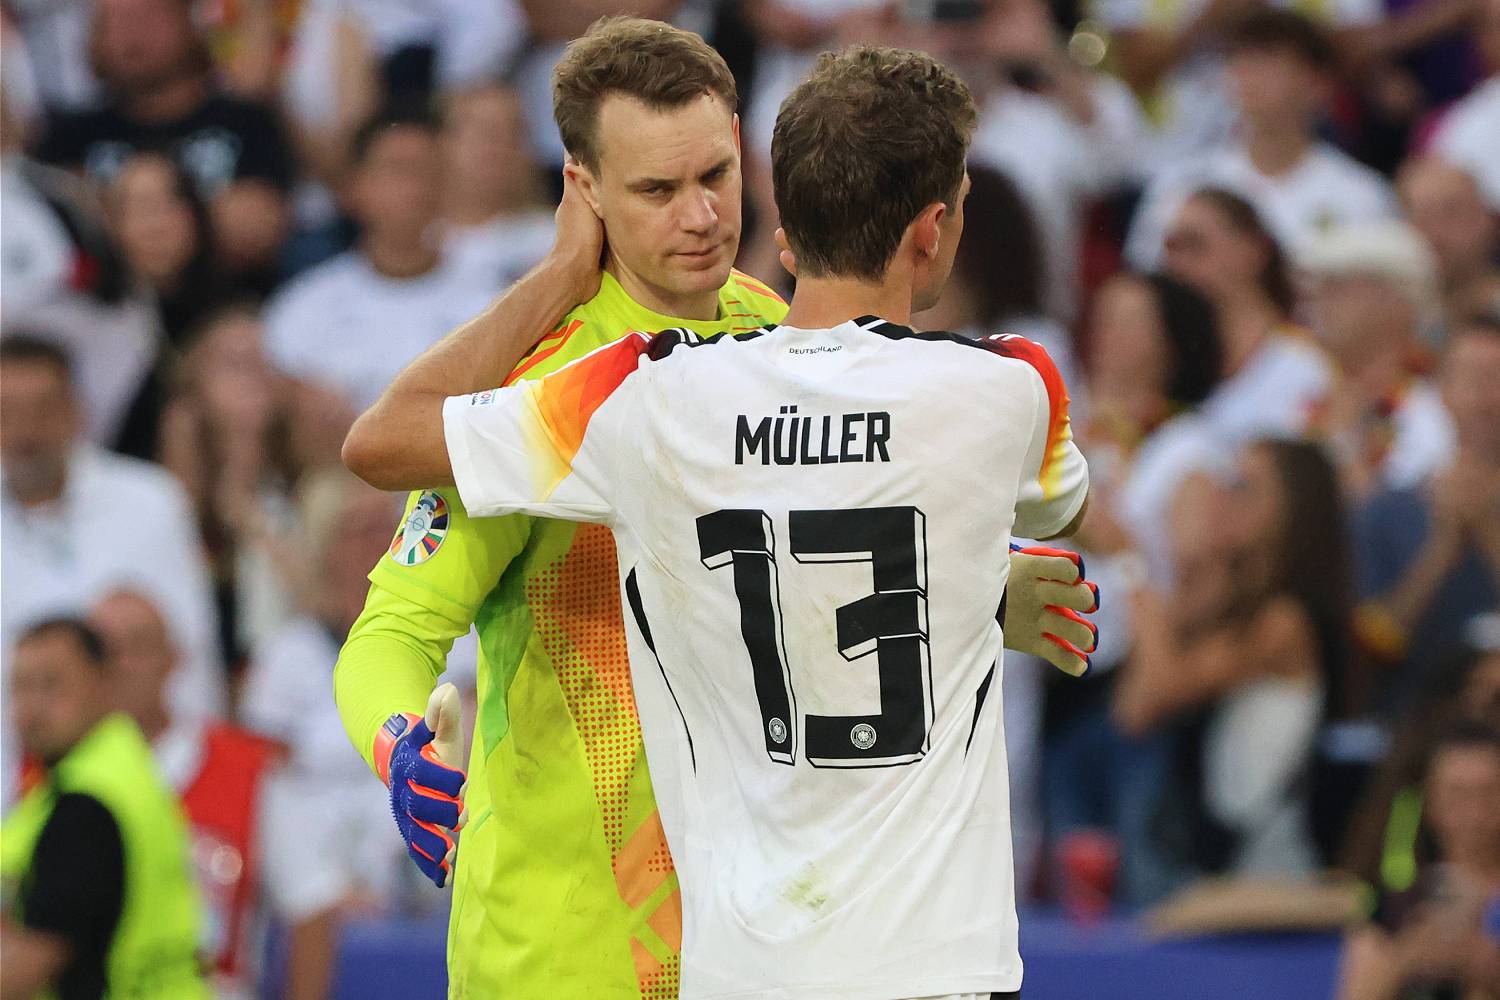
top-left (339, 271), bottom-right (786, 1000)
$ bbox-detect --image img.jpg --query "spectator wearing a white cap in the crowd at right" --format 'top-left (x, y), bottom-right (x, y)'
top-left (1305, 222), bottom-right (1455, 498)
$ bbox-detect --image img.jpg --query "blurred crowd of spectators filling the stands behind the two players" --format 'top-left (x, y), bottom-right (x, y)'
top-left (0, 0), bottom-right (1500, 1000)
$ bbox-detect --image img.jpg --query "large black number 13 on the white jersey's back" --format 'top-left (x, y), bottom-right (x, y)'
top-left (698, 507), bottom-right (933, 768)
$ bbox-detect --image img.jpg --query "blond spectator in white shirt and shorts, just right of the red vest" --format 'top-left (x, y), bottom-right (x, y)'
top-left (240, 469), bottom-right (417, 997)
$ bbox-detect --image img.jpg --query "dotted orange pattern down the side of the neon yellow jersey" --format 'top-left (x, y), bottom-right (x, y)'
top-left (527, 525), bottom-right (683, 1000)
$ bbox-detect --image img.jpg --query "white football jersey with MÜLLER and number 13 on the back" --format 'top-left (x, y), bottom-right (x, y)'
top-left (444, 318), bottom-right (1088, 1000)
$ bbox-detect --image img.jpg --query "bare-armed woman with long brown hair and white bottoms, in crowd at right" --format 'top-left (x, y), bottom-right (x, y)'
top-left (1115, 439), bottom-right (1352, 874)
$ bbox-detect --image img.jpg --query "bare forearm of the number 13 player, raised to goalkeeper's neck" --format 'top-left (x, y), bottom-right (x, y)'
top-left (344, 261), bottom-right (578, 490)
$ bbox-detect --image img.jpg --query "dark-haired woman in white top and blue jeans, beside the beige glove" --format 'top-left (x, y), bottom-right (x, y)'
top-left (1046, 271), bottom-right (1221, 903)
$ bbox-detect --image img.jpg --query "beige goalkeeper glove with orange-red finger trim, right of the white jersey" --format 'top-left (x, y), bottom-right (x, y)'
top-left (1001, 544), bottom-right (1100, 678)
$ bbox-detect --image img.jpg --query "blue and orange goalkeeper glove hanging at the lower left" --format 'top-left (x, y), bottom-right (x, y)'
top-left (375, 684), bottom-right (468, 888)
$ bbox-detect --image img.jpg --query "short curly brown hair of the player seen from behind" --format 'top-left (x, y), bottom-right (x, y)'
top-left (771, 45), bottom-right (978, 279)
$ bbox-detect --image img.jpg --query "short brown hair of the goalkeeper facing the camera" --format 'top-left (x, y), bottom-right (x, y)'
top-left (552, 16), bottom-right (740, 169)
